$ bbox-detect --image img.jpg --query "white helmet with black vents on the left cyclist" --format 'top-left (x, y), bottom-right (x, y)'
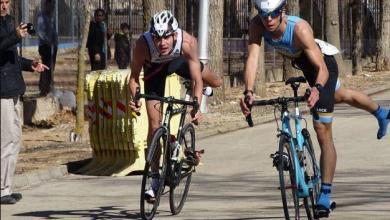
top-left (149, 10), bottom-right (178, 37)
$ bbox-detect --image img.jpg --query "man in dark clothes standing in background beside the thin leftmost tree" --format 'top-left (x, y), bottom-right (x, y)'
top-left (37, 0), bottom-right (58, 96)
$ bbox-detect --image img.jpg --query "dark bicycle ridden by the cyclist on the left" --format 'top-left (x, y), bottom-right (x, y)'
top-left (134, 81), bottom-right (204, 220)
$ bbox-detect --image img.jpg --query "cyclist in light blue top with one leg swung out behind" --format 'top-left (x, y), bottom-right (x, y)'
top-left (241, 0), bottom-right (390, 217)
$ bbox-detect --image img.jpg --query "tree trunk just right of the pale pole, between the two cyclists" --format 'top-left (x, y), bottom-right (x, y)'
top-left (208, 0), bottom-right (225, 102)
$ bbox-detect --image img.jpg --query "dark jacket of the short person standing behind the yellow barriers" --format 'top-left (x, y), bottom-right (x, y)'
top-left (114, 33), bottom-right (130, 69)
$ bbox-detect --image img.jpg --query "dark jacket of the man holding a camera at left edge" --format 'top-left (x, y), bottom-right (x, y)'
top-left (0, 15), bottom-right (33, 98)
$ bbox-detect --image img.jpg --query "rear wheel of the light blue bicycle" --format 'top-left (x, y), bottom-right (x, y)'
top-left (302, 129), bottom-right (321, 219)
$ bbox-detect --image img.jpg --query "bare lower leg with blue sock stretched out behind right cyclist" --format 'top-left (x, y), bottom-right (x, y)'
top-left (335, 88), bottom-right (390, 139)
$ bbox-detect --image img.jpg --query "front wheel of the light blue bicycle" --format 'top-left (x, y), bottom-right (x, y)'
top-left (278, 135), bottom-right (299, 219)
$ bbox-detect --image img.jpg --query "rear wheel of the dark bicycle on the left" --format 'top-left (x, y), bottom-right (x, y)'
top-left (169, 124), bottom-right (195, 215)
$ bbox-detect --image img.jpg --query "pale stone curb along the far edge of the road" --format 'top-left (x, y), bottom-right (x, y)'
top-left (13, 85), bottom-right (390, 190)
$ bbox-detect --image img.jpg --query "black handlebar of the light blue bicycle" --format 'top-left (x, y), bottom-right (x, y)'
top-left (245, 89), bottom-right (319, 127)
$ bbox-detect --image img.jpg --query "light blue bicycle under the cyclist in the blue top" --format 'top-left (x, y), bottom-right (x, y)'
top-left (246, 76), bottom-right (327, 219)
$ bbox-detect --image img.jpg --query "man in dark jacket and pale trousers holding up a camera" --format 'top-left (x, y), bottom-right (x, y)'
top-left (0, 0), bottom-right (49, 205)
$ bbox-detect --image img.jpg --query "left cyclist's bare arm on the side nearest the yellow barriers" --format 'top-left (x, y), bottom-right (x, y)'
top-left (129, 36), bottom-right (148, 111)
